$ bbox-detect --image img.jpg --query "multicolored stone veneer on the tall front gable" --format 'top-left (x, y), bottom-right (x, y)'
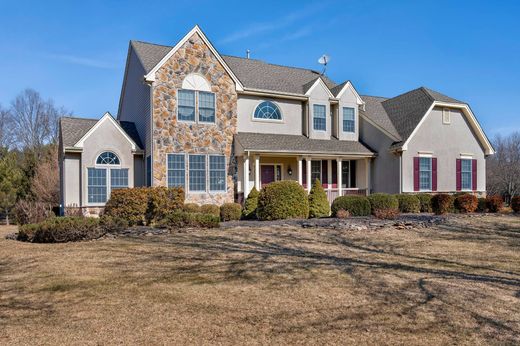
top-left (152, 33), bottom-right (237, 204)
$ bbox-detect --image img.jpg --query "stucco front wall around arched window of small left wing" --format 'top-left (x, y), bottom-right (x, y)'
top-left (81, 120), bottom-right (134, 206)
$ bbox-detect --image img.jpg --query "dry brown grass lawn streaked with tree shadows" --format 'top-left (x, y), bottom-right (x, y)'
top-left (0, 215), bottom-right (520, 344)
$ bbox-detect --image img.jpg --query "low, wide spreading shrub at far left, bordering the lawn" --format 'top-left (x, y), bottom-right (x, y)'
top-left (17, 217), bottom-right (106, 243)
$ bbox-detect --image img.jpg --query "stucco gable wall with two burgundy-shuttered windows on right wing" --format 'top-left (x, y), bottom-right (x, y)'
top-left (403, 108), bottom-right (486, 192)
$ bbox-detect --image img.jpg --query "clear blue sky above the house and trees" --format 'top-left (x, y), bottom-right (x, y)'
top-left (0, 0), bottom-right (520, 136)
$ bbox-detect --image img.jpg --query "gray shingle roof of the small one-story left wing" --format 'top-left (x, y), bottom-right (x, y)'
top-left (60, 117), bottom-right (143, 149)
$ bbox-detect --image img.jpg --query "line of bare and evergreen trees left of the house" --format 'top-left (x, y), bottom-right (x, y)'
top-left (0, 89), bottom-right (70, 224)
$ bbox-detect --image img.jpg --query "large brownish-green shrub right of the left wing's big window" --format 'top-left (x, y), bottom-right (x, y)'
top-left (105, 187), bottom-right (148, 226)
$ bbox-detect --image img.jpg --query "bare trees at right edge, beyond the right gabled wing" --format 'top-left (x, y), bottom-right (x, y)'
top-left (487, 132), bottom-right (520, 199)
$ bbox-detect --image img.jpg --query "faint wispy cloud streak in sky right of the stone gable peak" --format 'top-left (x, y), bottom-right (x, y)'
top-left (219, 3), bottom-right (324, 44)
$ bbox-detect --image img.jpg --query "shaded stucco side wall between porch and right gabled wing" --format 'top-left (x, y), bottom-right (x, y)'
top-left (359, 119), bottom-right (399, 193)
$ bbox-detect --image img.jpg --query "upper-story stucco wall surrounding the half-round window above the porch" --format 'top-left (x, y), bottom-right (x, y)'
top-left (237, 95), bottom-right (302, 135)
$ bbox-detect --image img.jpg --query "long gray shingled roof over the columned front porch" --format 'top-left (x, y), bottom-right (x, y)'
top-left (235, 132), bottom-right (376, 157)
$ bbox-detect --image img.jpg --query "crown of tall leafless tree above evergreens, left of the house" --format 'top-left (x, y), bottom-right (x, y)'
top-left (11, 89), bottom-right (67, 150)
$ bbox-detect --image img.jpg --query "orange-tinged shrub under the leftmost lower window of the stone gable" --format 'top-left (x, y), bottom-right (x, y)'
top-left (146, 186), bottom-right (184, 224)
